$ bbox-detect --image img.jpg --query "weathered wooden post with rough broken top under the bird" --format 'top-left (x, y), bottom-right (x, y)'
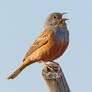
top-left (42, 63), bottom-right (70, 92)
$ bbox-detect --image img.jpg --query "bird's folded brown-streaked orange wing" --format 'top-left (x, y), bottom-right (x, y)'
top-left (23, 30), bottom-right (52, 61)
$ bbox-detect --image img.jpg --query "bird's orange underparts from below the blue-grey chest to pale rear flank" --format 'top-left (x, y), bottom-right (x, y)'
top-left (29, 32), bottom-right (69, 62)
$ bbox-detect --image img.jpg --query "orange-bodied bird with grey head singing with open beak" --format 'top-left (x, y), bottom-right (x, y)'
top-left (7, 12), bottom-right (69, 80)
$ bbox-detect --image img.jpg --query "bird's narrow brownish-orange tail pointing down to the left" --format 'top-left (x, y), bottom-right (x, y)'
top-left (7, 64), bottom-right (25, 80)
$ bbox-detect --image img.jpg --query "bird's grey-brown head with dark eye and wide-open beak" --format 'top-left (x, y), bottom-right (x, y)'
top-left (45, 13), bottom-right (67, 28)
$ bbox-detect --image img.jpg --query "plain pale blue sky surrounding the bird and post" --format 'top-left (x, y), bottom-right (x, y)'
top-left (0, 0), bottom-right (92, 92)
